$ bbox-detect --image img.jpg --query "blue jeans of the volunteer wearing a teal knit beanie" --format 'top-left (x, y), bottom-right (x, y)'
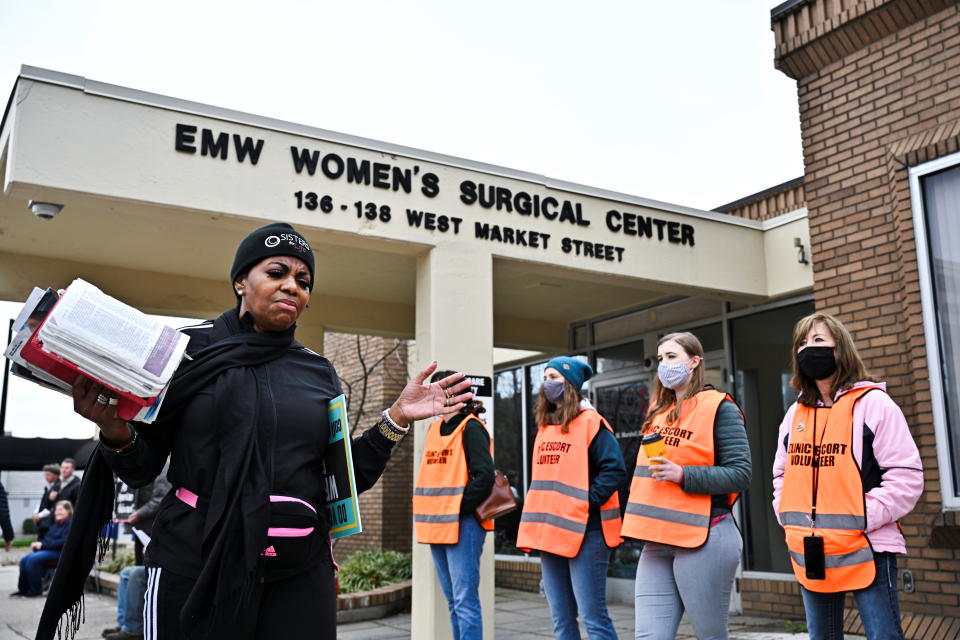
top-left (540, 529), bottom-right (617, 640)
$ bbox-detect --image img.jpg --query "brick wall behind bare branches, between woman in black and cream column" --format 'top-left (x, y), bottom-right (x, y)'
top-left (323, 332), bottom-right (413, 560)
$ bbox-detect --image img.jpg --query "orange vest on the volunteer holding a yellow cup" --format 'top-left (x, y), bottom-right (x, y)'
top-left (623, 389), bottom-right (739, 549)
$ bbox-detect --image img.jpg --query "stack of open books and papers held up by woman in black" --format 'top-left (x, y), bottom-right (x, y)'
top-left (4, 279), bottom-right (189, 422)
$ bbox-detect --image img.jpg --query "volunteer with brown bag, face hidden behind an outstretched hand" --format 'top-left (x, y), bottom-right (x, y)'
top-left (413, 371), bottom-right (494, 640)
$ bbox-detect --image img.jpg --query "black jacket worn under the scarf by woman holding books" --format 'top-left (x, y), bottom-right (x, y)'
top-left (101, 314), bottom-right (393, 578)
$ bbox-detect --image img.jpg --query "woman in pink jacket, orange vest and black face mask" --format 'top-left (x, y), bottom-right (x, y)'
top-left (773, 313), bottom-right (923, 640)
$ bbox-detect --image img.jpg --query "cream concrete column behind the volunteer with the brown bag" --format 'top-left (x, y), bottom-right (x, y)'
top-left (411, 245), bottom-right (494, 640)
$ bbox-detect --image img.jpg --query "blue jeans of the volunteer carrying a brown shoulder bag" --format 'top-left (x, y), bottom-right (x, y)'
top-left (430, 515), bottom-right (487, 640)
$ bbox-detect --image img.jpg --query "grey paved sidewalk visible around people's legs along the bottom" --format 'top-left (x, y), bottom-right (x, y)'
top-left (0, 566), bottom-right (862, 640)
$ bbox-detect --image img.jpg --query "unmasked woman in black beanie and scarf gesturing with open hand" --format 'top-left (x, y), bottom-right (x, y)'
top-left (37, 223), bottom-right (472, 640)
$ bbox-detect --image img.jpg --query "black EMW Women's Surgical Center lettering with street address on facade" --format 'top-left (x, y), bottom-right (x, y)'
top-left (173, 122), bottom-right (696, 263)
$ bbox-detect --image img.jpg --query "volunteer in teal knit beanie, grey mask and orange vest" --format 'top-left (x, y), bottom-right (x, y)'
top-left (517, 356), bottom-right (627, 640)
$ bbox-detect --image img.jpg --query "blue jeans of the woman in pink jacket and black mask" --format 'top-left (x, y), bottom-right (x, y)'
top-left (800, 552), bottom-right (903, 640)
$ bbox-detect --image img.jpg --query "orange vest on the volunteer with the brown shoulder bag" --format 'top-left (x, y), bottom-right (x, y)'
top-left (413, 415), bottom-right (493, 544)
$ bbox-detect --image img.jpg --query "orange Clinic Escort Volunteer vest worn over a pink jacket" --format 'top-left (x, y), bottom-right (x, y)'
top-left (778, 386), bottom-right (882, 593)
